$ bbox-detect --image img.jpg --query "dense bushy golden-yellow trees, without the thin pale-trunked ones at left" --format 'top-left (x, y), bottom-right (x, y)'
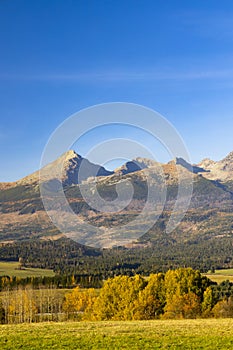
top-left (62, 268), bottom-right (233, 320)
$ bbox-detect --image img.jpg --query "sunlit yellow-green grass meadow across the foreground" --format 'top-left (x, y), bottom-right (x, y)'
top-left (0, 319), bottom-right (233, 350)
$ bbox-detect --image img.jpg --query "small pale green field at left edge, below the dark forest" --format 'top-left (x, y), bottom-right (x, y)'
top-left (0, 261), bottom-right (54, 278)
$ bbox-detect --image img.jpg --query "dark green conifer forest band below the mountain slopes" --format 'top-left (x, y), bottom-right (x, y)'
top-left (0, 234), bottom-right (233, 279)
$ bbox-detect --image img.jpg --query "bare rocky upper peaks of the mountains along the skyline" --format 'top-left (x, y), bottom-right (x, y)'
top-left (0, 150), bottom-right (233, 190)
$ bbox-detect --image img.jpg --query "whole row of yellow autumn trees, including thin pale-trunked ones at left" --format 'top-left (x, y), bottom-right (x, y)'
top-left (0, 268), bottom-right (233, 323)
